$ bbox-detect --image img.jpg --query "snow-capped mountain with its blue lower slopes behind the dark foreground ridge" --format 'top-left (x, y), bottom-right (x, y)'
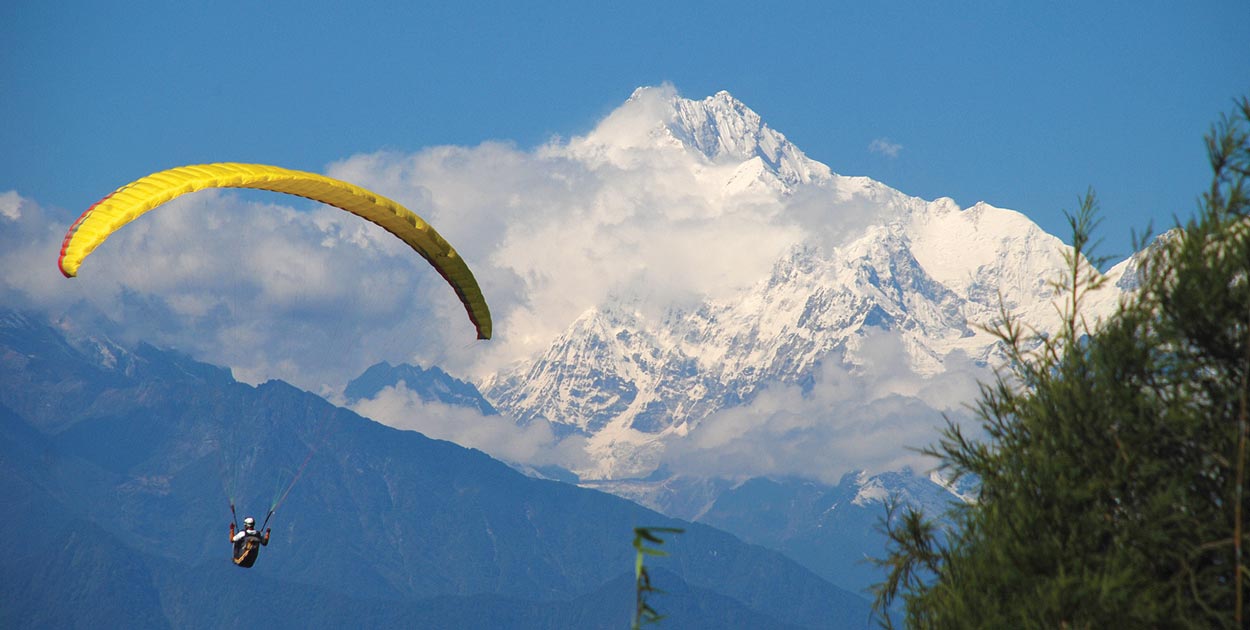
top-left (327, 89), bottom-right (1135, 600)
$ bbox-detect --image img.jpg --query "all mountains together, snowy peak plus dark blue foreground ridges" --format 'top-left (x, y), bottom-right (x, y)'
top-left (0, 89), bottom-right (1135, 628)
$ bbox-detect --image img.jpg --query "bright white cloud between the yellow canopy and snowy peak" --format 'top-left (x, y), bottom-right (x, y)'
top-left (330, 113), bottom-right (815, 376)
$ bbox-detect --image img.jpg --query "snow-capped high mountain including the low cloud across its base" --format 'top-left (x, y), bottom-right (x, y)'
top-left (483, 86), bottom-right (1121, 480)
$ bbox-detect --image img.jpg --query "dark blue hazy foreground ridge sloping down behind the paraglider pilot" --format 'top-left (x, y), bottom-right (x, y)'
top-left (0, 311), bottom-right (869, 628)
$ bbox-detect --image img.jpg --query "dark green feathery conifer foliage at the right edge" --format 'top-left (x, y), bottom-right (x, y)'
top-left (875, 99), bottom-right (1250, 629)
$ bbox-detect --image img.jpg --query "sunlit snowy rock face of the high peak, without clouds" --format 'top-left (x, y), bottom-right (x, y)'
top-left (480, 88), bottom-right (1124, 480)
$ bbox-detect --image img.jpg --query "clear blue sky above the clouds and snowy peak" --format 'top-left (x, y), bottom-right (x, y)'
top-left (0, 0), bottom-right (1250, 254)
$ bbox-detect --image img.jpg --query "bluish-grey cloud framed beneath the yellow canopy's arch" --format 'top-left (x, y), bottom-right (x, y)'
top-left (0, 191), bottom-right (474, 391)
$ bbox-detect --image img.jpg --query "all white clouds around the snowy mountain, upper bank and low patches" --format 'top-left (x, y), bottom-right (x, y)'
top-left (0, 88), bottom-right (975, 480)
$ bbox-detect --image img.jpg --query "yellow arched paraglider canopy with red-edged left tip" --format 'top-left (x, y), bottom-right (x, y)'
top-left (59, 163), bottom-right (491, 339)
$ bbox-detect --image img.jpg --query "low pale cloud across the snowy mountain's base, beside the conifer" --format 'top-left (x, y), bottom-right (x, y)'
top-left (664, 333), bottom-right (988, 484)
